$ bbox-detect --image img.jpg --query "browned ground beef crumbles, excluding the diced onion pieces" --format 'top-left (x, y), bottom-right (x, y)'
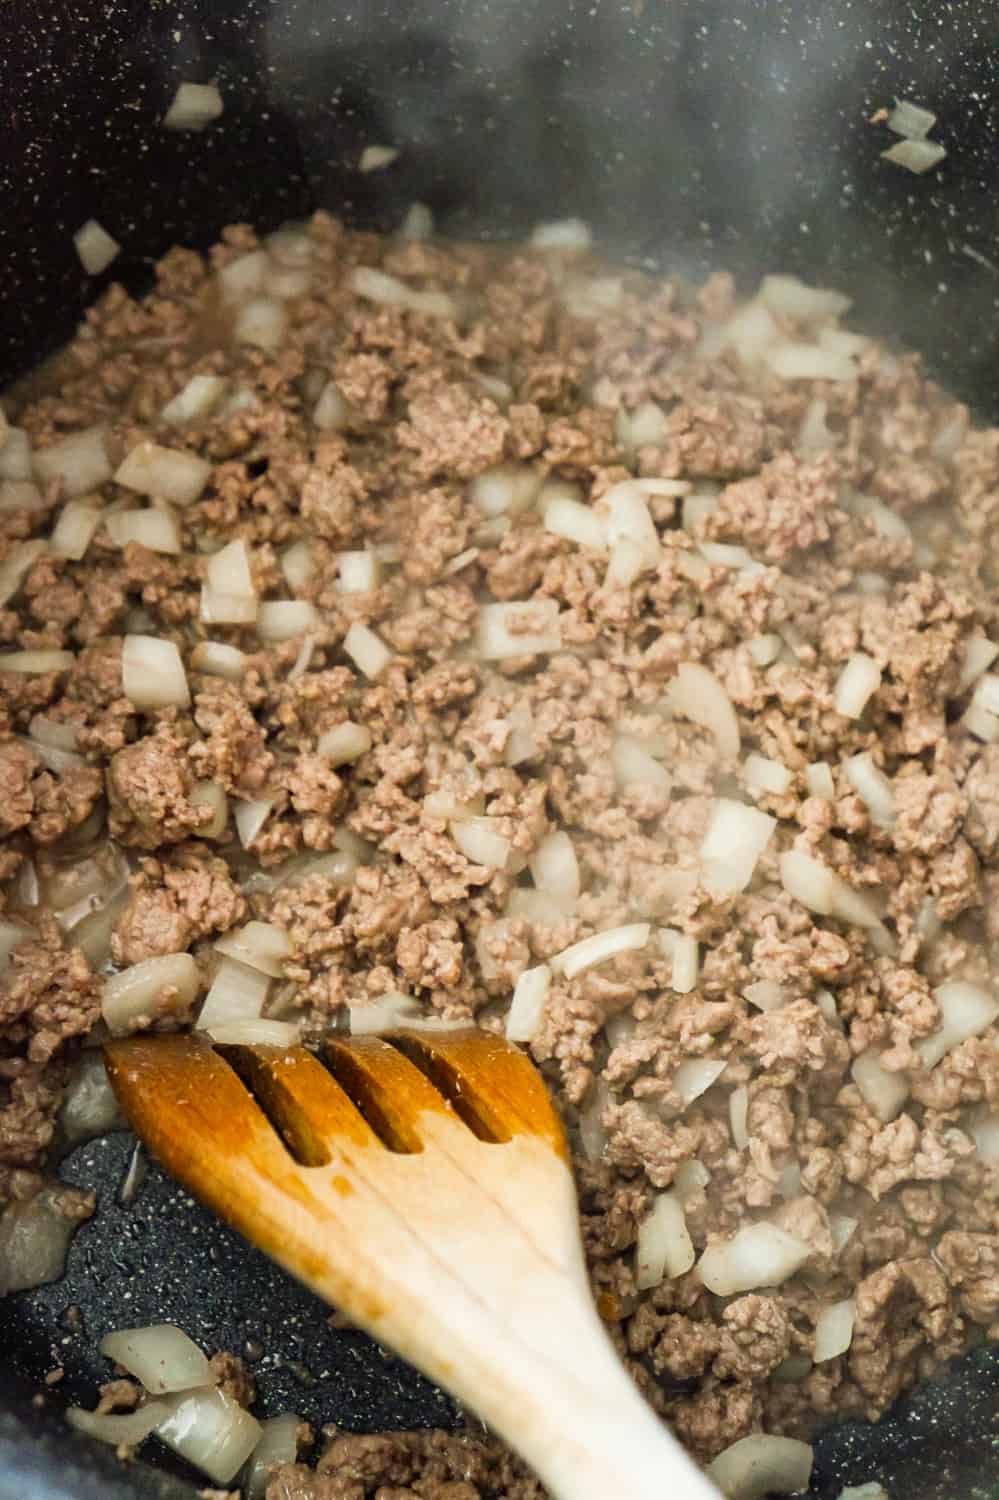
top-left (0, 215), bottom-right (999, 1500)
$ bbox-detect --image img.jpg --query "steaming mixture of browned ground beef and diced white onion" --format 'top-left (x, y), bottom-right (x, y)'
top-left (0, 215), bottom-right (999, 1500)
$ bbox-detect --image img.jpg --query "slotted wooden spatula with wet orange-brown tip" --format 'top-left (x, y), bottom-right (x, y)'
top-left (105, 1031), bottom-right (717, 1500)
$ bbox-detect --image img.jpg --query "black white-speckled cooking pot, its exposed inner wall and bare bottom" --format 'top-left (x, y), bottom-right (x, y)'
top-left (0, 0), bottom-right (999, 1500)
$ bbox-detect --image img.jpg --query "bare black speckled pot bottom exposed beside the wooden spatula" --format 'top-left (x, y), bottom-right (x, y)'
top-left (0, 1131), bottom-right (999, 1500)
